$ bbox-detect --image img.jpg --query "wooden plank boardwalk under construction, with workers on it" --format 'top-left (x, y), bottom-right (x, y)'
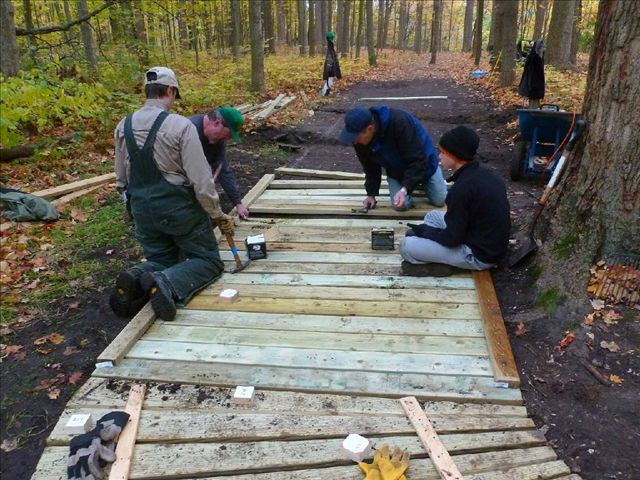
top-left (33, 175), bottom-right (578, 480)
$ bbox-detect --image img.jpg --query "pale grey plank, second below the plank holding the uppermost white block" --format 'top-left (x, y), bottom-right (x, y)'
top-left (170, 309), bottom-right (484, 339)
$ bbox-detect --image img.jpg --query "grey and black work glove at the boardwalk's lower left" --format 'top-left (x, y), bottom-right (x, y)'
top-left (67, 412), bottom-right (129, 480)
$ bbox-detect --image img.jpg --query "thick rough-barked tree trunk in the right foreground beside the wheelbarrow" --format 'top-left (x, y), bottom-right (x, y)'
top-left (537, 0), bottom-right (640, 306)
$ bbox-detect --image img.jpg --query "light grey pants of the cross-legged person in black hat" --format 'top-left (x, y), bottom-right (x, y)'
top-left (400, 210), bottom-right (494, 270)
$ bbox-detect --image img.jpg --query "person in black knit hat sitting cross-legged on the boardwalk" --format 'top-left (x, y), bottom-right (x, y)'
top-left (400, 126), bottom-right (511, 277)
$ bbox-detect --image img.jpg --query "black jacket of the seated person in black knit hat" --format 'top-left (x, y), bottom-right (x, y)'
top-left (416, 161), bottom-right (511, 263)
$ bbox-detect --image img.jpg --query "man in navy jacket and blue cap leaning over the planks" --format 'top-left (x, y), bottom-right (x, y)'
top-left (340, 106), bottom-right (447, 210)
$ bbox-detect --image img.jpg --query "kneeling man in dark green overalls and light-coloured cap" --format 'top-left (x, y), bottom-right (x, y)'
top-left (109, 67), bottom-right (233, 320)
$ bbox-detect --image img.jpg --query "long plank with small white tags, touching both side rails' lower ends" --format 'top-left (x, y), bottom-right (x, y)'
top-left (93, 358), bottom-right (522, 405)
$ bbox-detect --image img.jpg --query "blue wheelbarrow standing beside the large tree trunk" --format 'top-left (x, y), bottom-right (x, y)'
top-left (509, 104), bottom-right (581, 182)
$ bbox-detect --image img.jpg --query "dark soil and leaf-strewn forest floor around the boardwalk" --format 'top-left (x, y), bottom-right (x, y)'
top-left (0, 54), bottom-right (640, 480)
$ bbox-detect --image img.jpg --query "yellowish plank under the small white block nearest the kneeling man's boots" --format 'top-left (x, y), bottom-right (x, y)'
top-left (199, 279), bottom-right (478, 304)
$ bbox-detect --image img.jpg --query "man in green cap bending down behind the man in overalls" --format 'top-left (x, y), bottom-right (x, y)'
top-left (189, 107), bottom-right (249, 220)
